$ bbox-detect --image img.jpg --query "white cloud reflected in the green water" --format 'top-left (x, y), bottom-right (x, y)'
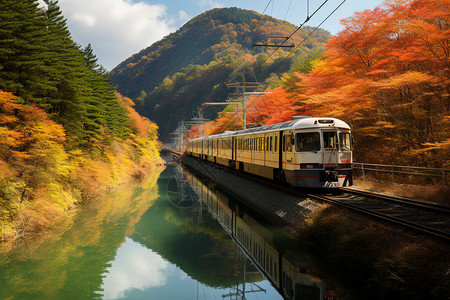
top-left (102, 238), bottom-right (176, 299)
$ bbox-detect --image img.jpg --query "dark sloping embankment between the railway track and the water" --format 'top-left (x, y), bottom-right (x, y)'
top-left (182, 157), bottom-right (450, 299)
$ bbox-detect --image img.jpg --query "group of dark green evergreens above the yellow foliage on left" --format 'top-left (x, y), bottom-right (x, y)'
top-left (0, 0), bottom-right (130, 147)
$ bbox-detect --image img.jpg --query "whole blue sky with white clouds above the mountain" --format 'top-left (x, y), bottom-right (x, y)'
top-left (49, 0), bottom-right (383, 70)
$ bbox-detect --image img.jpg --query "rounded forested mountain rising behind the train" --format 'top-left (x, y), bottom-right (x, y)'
top-left (110, 8), bottom-right (330, 139)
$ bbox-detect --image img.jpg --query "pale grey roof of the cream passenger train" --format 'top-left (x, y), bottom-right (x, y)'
top-left (192, 116), bottom-right (350, 141)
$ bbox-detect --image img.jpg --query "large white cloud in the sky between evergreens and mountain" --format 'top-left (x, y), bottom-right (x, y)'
top-left (55, 0), bottom-right (176, 69)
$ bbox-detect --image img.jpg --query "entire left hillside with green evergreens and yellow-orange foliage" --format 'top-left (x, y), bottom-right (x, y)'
top-left (0, 0), bottom-right (158, 240)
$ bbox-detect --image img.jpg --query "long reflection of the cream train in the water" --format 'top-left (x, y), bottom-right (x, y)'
top-left (188, 175), bottom-right (334, 300)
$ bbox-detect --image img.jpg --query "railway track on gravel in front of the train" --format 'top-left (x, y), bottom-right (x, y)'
top-left (308, 188), bottom-right (450, 242)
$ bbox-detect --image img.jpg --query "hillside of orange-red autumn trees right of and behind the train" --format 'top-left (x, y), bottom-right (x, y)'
top-left (199, 0), bottom-right (450, 168)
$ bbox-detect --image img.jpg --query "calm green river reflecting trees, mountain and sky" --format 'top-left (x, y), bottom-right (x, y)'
top-left (0, 158), bottom-right (312, 299)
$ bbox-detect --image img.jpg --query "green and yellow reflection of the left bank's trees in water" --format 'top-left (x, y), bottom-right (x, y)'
top-left (0, 170), bottom-right (161, 300)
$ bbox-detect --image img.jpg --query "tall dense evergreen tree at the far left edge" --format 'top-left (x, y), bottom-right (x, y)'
top-left (0, 0), bottom-right (55, 108)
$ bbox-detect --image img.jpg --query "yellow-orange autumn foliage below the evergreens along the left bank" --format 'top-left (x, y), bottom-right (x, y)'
top-left (0, 91), bottom-right (159, 241)
